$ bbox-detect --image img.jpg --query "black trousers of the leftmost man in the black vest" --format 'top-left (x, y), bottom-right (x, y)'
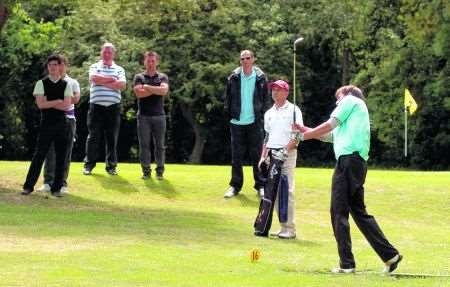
top-left (23, 122), bottom-right (69, 192)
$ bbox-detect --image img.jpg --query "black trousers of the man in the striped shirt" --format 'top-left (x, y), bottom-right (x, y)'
top-left (84, 104), bottom-right (120, 169)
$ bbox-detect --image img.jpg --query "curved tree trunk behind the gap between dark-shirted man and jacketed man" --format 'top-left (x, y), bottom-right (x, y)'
top-left (180, 104), bottom-right (207, 164)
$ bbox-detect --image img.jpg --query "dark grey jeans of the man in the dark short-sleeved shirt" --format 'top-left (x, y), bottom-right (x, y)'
top-left (137, 115), bottom-right (166, 174)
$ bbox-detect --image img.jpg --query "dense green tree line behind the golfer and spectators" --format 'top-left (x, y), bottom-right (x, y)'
top-left (0, 0), bottom-right (450, 169)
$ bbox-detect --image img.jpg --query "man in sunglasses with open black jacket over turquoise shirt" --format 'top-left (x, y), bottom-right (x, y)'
top-left (224, 50), bottom-right (272, 198)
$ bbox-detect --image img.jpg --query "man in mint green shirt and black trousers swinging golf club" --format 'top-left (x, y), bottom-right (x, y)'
top-left (298, 85), bottom-right (402, 273)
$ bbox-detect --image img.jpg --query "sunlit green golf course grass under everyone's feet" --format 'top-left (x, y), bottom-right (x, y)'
top-left (0, 161), bottom-right (450, 287)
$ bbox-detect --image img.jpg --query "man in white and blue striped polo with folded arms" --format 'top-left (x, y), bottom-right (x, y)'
top-left (83, 43), bottom-right (126, 175)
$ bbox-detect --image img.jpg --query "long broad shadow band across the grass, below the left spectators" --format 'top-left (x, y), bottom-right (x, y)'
top-left (0, 188), bottom-right (246, 248)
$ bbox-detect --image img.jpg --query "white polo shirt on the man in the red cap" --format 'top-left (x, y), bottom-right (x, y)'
top-left (264, 101), bottom-right (303, 148)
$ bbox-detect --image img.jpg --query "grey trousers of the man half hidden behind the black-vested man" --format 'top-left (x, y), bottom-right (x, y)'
top-left (44, 119), bottom-right (77, 186)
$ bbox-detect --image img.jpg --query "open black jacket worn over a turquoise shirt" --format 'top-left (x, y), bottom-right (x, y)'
top-left (224, 67), bottom-right (272, 122)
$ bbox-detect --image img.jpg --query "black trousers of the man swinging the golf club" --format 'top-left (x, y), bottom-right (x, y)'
top-left (330, 153), bottom-right (398, 268)
